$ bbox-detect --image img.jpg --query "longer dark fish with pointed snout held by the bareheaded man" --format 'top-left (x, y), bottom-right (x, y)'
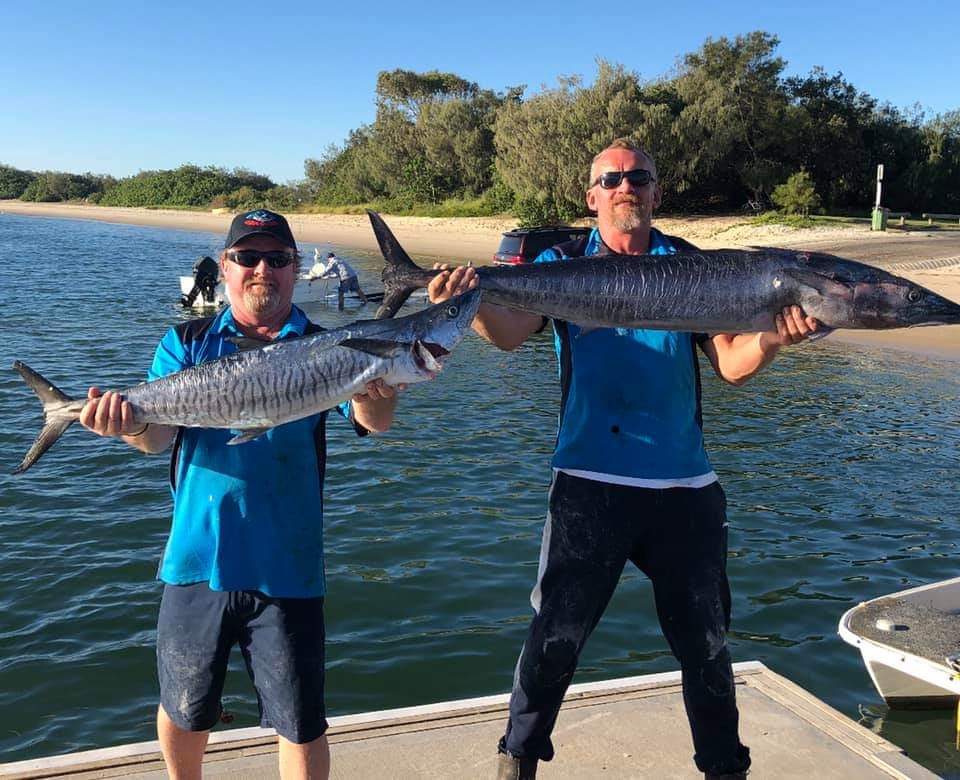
top-left (368, 211), bottom-right (960, 335)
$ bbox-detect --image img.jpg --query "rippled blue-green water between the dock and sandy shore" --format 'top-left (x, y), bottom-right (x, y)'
top-left (0, 215), bottom-right (960, 777)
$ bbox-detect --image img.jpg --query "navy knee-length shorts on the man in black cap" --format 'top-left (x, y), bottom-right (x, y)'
top-left (157, 582), bottom-right (327, 744)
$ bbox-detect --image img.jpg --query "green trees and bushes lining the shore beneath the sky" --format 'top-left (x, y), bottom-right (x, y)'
top-left (0, 31), bottom-right (960, 224)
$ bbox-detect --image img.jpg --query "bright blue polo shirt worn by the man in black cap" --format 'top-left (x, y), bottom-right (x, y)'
top-left (148, 306), bottom-right (363, 598)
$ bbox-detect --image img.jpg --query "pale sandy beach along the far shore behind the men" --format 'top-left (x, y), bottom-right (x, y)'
top-left (0, 200), bottom-right (960, 360)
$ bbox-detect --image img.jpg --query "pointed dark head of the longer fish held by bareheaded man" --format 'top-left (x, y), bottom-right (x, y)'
top-left (792, 254), bottom-right (960, 330)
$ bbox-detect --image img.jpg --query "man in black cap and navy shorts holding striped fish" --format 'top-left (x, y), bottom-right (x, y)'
top-left (80, 209), bottom-right (397, 779)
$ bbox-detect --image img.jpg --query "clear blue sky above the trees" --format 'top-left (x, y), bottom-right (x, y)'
top-left (0, 0), bottom-right (960, 182)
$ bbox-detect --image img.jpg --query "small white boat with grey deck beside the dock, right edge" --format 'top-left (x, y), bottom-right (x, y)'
top-left (838, 577), bottom-right (960, 709)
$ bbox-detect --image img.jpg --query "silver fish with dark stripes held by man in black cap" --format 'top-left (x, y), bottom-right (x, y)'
top-left (13, 290), bottom-right (480, 474)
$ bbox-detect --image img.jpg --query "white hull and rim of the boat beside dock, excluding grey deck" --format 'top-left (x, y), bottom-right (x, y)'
top-left (838, 577), bottom-right (960, 707)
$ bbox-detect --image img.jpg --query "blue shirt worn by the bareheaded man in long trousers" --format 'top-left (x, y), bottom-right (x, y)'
top-left (536, 228), bottom-right (717, 488)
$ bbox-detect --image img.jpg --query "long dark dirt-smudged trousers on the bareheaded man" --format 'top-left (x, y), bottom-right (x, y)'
top-left (500, 472), bottom-right (750, 774)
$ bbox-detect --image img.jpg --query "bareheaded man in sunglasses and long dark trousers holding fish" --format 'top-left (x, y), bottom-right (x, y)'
top-left (428, 139), bottom-right (817, 780)
